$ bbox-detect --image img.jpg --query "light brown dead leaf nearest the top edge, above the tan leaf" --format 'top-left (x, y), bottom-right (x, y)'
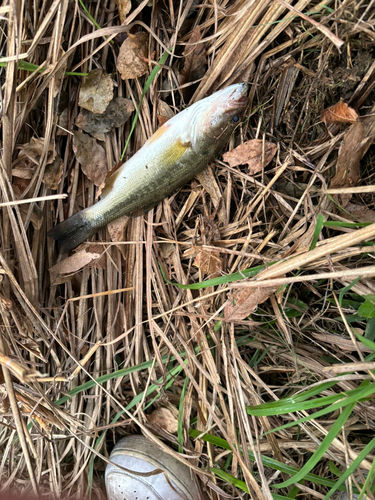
top-left (117, 31), bottom-right (148, 80)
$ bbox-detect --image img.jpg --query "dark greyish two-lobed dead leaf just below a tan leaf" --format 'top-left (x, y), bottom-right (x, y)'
top-left (76, 97), bottom-right (135, 141)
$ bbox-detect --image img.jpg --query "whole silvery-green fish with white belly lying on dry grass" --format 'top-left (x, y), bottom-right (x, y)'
top-left (48, 83), bottom-right (248, 253)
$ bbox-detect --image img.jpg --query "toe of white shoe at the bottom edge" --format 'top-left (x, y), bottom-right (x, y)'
top-left (105, 436), bottom-right (200, 500)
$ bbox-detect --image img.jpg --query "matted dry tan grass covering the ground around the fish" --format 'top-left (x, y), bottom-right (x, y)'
top-left (0, 0), bottom-right (375, 499)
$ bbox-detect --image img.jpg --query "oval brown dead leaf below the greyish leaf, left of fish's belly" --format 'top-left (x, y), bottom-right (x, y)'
top-left (73, 132), bottom-right (108, 186)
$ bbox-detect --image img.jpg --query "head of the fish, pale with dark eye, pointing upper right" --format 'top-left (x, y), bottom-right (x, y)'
top-left (191, 83), bottom-right (248, 153)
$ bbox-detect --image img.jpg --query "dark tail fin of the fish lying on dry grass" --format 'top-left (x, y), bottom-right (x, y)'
top-left (48, 210), bottom-right (99, 253)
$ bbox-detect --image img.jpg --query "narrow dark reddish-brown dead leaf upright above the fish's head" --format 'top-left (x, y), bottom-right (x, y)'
top-left (179, 26), bottom-right (207, 95)
